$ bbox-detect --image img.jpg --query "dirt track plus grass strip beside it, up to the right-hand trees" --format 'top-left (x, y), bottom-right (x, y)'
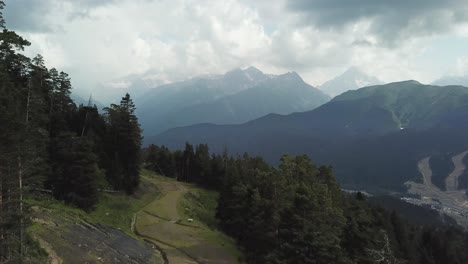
top-left (135, 176), bottom-right (242, 264)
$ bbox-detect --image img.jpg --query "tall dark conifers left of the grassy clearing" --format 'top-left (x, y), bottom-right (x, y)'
top-left (0, 1), bottom-right (141, 263)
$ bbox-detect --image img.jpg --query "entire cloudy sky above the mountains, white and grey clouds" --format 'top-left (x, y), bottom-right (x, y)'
top-left (4, 0), bottom-right (468, 96)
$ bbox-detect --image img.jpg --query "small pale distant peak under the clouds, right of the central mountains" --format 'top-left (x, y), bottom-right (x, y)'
top-left (319, 67), bottom-right (382, 97)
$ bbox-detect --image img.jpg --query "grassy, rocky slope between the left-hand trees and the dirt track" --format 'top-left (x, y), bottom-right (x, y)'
top-left (28, 172), bottom-right (165, 263)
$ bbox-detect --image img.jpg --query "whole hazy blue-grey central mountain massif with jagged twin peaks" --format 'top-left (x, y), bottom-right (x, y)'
top-left (137, 67), bottom-right (329, 135)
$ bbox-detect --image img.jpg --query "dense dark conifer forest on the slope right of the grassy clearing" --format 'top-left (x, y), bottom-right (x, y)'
top-left (144, 144), bottom-right (468, 264)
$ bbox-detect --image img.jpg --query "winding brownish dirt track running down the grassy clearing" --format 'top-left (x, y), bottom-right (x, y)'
top-left (135, 177), bottom-right (238, 264)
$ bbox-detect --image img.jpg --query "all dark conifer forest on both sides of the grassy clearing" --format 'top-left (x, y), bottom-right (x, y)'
top-left (0, 1), bottom-right (468, 264)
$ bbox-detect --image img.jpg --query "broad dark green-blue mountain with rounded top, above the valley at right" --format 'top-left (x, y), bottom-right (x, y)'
top-left (149, 81), bottom-right (468, 189)
